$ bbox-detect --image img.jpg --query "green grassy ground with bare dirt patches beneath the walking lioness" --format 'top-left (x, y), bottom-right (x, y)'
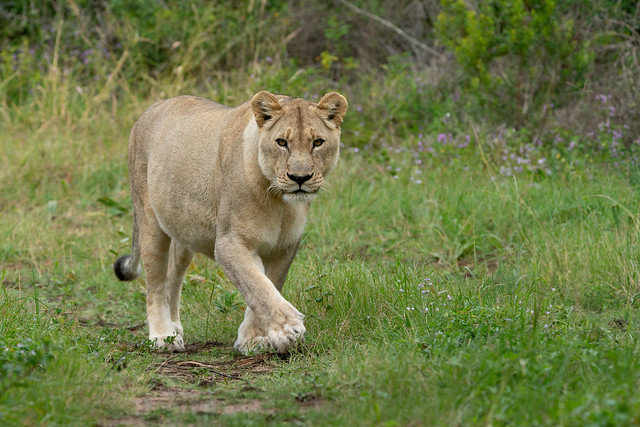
top-left (0, 82), bottom-right (640, 426)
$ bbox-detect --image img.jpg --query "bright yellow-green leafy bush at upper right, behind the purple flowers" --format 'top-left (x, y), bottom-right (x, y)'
top-left (436, 0), bottom-right (593, 127)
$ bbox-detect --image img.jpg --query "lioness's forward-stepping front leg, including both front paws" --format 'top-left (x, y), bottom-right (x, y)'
top-left (215, 239), bottom-right (306, 354)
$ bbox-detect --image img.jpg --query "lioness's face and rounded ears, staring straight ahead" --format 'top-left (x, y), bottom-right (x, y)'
top-left (252, 92), bottom-right (347, 203)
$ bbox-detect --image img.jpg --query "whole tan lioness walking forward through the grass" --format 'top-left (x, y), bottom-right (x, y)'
top-left (113, 91), bottom-right (347, 354)
